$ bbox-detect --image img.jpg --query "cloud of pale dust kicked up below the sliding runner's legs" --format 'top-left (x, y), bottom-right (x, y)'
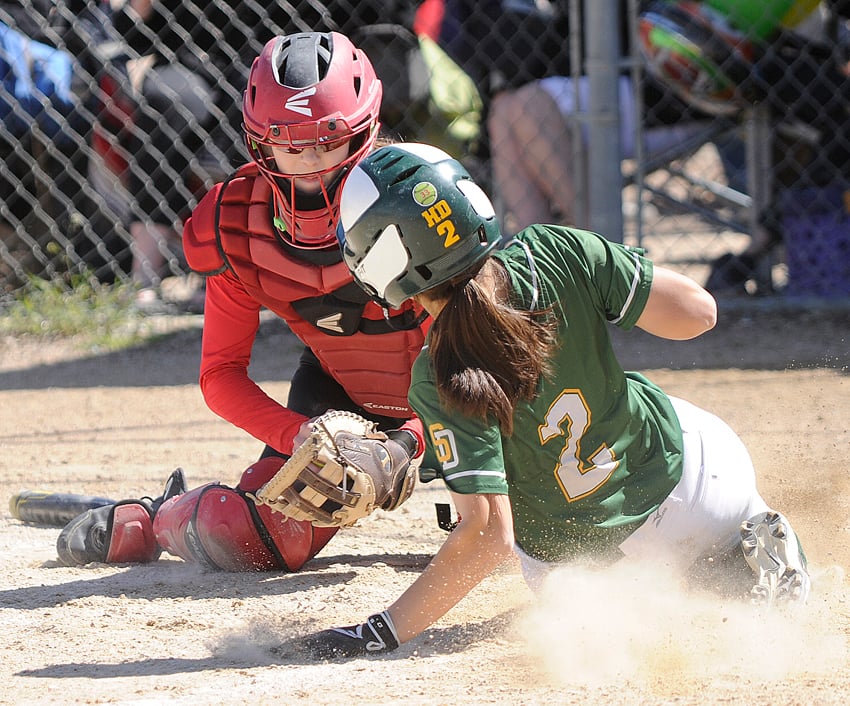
top-left (518, 565), bottom-right (850, 686)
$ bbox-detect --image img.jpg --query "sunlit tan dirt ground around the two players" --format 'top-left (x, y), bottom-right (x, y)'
top-left (0, 309), bottom-right (850, 706)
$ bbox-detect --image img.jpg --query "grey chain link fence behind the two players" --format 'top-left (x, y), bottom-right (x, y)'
top-left (0, 0), bottom-right (850, 298)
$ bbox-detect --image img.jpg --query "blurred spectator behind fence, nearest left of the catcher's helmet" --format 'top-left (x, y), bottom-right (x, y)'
top-left (104, 0), bottom-right (215, 310)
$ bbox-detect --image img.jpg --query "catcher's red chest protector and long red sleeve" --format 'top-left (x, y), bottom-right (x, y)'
top-left (183, 165), bottom-right (427, 453)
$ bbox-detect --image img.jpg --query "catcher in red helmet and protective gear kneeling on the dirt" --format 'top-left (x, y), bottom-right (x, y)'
top-left (57, 32), bottom-right (426, 571)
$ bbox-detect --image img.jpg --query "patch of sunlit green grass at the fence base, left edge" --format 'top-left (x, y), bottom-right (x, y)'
top-left (0, 275), bottom-right (164, 351)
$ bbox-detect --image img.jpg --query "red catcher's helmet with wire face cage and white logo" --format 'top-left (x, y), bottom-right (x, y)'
top-left (242, 32), bottom-right (382, 249)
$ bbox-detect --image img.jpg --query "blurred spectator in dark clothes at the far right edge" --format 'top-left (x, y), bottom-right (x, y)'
top-left (706, 0), bottom-right (850, 294)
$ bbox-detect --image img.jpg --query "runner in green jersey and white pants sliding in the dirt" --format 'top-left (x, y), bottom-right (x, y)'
top-left (300, 144), bottom-right (810, 658)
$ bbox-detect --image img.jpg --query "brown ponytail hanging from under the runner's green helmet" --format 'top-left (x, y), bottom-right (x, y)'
top-left (428, 258), bottom-right (557, 436)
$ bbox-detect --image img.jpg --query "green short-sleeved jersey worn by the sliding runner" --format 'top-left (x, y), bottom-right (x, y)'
top-left (409, 225), bottom-right (682, 561)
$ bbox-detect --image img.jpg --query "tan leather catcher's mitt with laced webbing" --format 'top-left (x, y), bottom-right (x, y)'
top-left (254, 411), bottom-right (416, 527)
